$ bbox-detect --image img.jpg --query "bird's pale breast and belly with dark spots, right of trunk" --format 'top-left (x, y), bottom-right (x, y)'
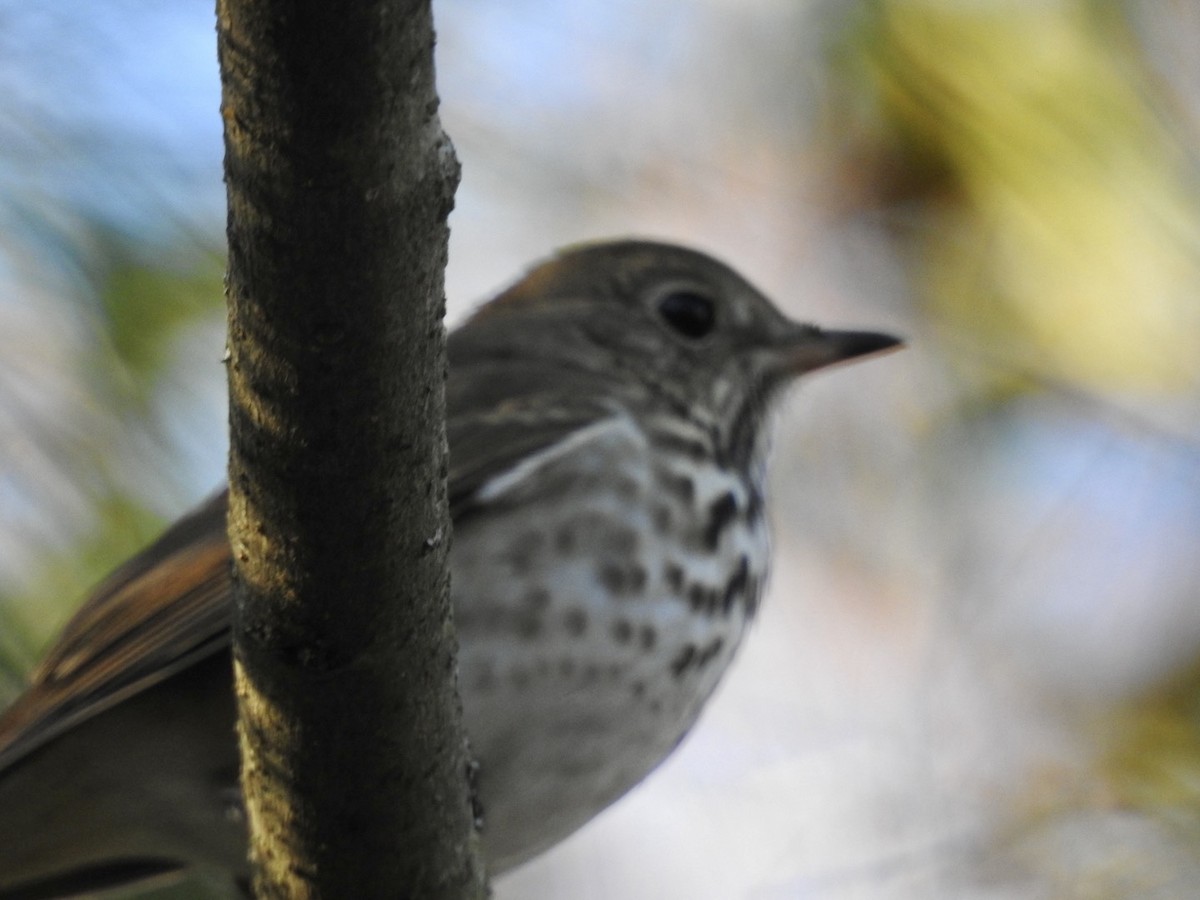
top-left (452, 458), bottom-right (768, 872)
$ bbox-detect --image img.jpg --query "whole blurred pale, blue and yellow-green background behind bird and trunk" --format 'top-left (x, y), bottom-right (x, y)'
top-left (0, 0), bottom-right (1200, 900)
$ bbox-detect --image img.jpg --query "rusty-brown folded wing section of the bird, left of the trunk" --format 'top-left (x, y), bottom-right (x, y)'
top-left (0, 492), bottom-right (232, 769)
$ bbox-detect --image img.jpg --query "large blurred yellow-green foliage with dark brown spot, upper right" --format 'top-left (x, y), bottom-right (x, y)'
top-left (838, 0), bottom-right (1200, 390)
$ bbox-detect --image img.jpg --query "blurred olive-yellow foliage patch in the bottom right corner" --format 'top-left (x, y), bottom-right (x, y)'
top-left (986, 660), bottom-right (1200, 900)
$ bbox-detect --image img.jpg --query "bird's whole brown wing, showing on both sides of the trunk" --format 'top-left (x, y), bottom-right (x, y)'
top-left (0, 367), bottom-right (608, 769)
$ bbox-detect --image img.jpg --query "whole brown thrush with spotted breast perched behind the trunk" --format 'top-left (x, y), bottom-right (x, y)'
top-left (0, 241), bottom-right (898, 898)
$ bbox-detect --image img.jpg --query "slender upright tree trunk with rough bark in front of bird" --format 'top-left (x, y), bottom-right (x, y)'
top-left (217, 0), bottom-right (486, 899)
